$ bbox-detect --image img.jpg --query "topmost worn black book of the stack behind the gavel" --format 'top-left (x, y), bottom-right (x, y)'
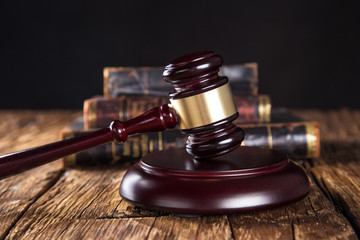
top-left (103, 63), bottom-right (258, 98)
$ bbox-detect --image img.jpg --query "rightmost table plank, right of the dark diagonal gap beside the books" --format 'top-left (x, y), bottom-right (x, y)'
top-left (295, 109), bottom-right (360, 234)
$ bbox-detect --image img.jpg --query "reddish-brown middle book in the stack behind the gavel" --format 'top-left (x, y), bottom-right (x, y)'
top-left (83, 95), bottom-right (271, 129)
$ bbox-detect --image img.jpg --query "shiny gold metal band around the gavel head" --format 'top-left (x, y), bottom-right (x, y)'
top-left (170, 83), bottom-right (237, 129)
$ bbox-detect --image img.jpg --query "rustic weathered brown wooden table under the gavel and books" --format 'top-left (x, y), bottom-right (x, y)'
top-left (0, 109), bottom-right (360, 239)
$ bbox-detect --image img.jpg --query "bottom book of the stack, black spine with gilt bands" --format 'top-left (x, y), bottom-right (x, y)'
top-left (60, 122), bottom-right (320, 166)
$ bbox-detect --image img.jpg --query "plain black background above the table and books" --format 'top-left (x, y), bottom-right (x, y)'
top-left (0, 0), bottom-right (360, 109)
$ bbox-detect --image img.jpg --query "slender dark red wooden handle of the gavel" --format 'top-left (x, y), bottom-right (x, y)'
top-left (0, 105), bottom-right (177, 179)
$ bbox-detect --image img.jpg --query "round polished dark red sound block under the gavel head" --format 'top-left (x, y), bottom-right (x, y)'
top-left (120, 147), bottom-right (310, 214)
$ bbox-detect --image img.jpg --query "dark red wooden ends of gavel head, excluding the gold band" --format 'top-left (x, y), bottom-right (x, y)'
top-left (163, 51), bottom-right (244, 159)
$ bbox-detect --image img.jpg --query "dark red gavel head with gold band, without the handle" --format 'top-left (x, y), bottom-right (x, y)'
top-left (163, 52), bottom-right (244, 159)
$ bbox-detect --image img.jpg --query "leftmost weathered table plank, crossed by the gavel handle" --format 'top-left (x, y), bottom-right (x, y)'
top-left (0, 110), bottom-right (79, 239)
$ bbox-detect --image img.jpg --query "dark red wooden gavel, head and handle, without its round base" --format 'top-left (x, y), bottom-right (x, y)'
top-left (0, 51), bottom-right (244, 178)
